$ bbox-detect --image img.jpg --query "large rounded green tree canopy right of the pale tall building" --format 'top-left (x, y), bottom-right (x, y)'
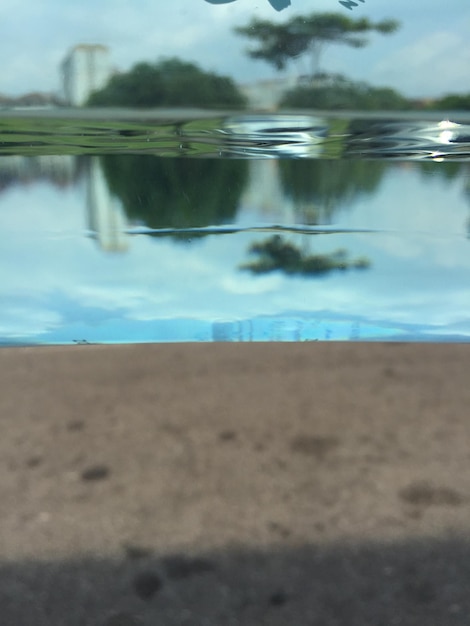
top-left (87, 58), bottom-right (246, 108)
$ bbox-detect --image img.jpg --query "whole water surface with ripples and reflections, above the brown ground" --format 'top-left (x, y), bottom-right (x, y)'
top-left (0, 109), bottom-right (470, 345)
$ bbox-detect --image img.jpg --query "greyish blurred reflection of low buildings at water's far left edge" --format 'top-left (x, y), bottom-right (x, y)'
top-left (0, 154), bottom-right (77, 191)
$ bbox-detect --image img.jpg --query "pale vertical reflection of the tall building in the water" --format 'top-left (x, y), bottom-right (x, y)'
top-left (86, 157), bottom-right (128, 252)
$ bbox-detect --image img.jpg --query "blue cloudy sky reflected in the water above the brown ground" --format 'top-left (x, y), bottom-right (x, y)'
top-left (0, 156), bottom-right (470, 343)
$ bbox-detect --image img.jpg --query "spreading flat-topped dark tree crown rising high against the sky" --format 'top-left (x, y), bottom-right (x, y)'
top-left (235, 13), bottom-right (399, 77)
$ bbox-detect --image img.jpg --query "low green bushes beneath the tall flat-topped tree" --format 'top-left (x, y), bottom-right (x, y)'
top-left (280, 76), bottom-right (411, 111)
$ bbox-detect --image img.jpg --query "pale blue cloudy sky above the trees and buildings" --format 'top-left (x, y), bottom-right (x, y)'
top-left (0, 0), bottom-right (470, 97)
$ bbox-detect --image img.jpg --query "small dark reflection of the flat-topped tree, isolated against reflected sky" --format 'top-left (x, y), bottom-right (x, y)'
top-left (240, 235), bottom-right (370, 276)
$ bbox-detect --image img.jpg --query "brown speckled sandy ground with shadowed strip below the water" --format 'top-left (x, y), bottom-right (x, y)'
top-left (0, 343), bottom-right (470, 626)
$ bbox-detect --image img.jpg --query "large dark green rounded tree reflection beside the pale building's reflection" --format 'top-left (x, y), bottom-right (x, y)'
top-left (103, 155), bottom-right (248, 236)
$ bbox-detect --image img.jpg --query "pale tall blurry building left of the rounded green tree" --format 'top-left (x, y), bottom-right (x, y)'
top-left (62, 44), bottom-right (112, 106)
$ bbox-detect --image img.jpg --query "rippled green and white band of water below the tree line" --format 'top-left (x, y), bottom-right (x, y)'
top-left (0, 109), bottom-right (470, 161)
